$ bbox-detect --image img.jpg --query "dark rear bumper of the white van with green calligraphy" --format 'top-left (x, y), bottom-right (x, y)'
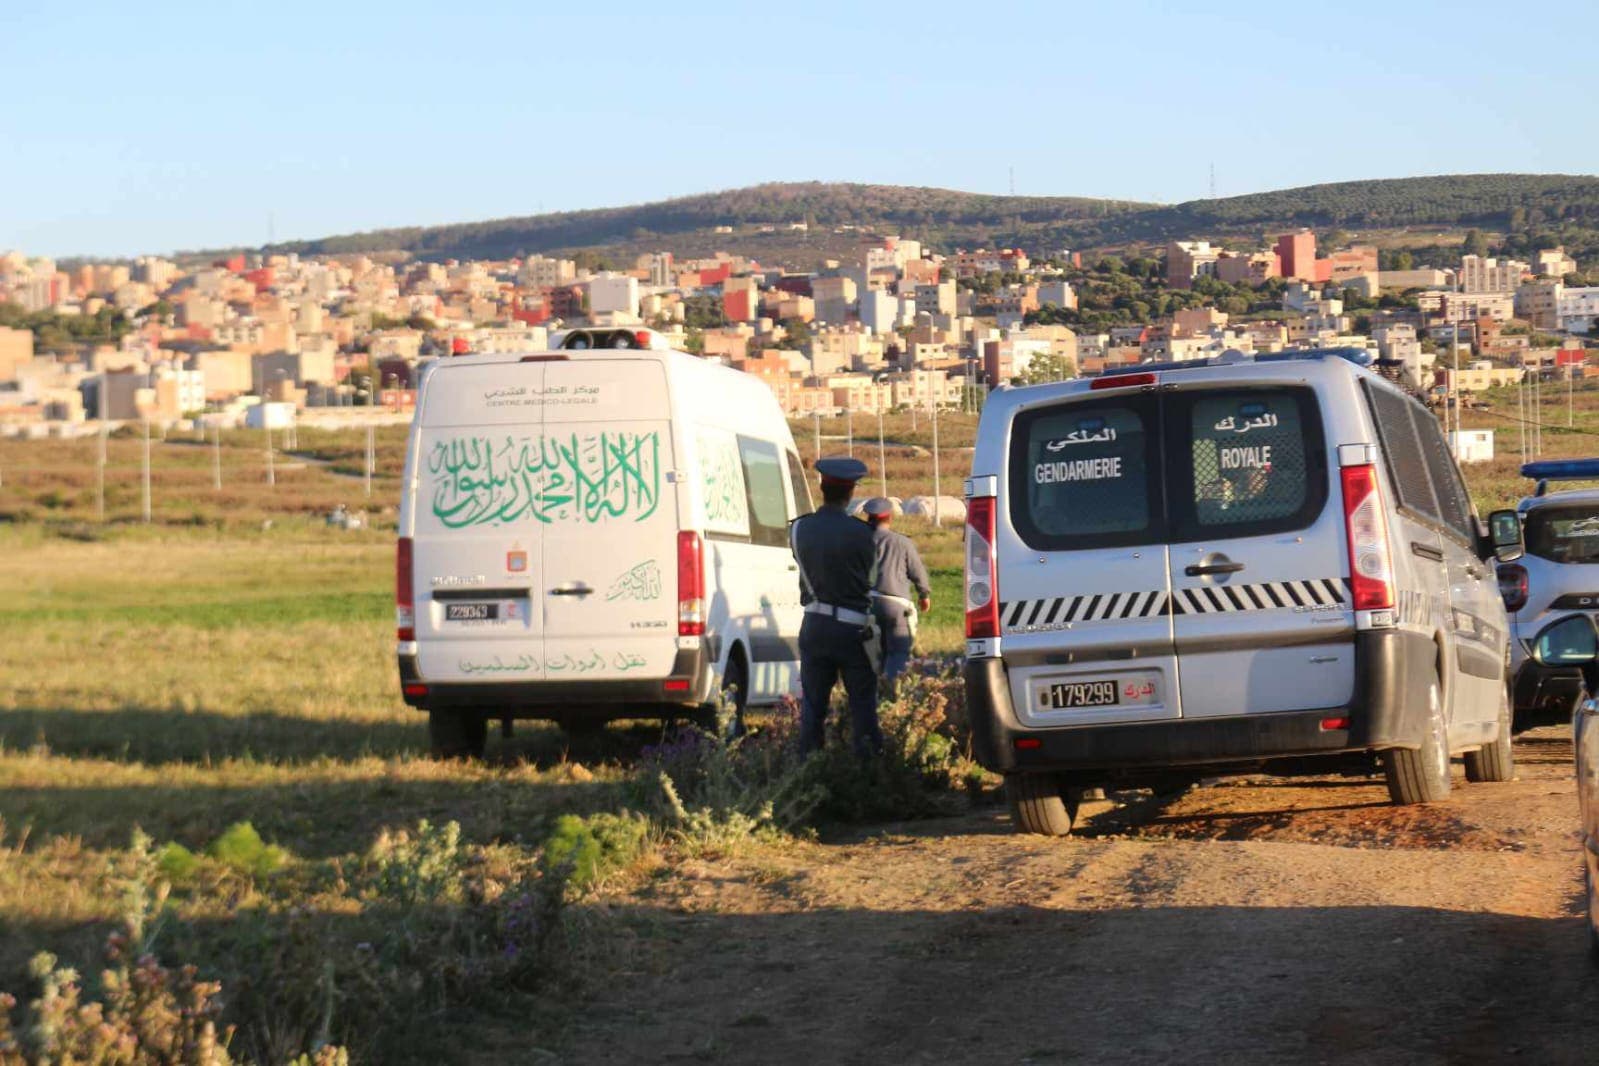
top-left (398, 649), bottom-right (715, 719)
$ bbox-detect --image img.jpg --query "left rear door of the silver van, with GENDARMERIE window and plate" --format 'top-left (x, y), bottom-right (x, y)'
top-left (996, 392), bottom-right (1182, 727)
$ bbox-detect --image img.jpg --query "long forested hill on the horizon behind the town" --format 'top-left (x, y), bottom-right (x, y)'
top-left (262, 174), bottom-right (1599, 259)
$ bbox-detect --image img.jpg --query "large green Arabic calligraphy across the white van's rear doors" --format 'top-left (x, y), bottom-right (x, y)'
top-left (427, 432), bottom-right (662, 529)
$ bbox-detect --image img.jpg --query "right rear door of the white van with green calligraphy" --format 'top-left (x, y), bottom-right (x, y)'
top-left (539, 355), bottom-right (681, 681)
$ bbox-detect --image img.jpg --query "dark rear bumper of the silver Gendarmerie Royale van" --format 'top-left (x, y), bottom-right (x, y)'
top-left (964, 630), bottom-right (1438, 775)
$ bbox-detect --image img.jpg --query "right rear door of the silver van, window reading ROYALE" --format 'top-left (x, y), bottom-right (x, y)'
top-left (1164, 384), bottom-right (1354, 718)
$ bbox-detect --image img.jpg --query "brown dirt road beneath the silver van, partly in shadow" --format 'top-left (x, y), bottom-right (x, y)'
top-left (540, 729), bottom-right (1599, 1064)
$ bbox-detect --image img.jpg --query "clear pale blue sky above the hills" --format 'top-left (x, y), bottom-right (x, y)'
top-left (0, 0), bottom-right (1599, 256)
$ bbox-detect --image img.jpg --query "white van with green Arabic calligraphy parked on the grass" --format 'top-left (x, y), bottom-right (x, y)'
top-left (397, 331), bottom-right (811, 754)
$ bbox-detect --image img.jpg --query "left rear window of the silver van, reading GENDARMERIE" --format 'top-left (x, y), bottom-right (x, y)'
top-left (1011, 396), bottom-right (1159, 548)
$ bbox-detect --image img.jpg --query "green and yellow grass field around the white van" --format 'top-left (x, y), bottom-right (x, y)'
top-left (0, 377), bottom-right (1599, 1061)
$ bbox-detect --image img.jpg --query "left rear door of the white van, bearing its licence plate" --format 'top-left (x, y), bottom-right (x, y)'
top-left (408, 363), bottom-right (545, 681)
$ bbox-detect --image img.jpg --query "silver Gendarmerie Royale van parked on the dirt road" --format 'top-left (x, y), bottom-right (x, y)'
top-left (966, 350), bottom-right (1521, 834)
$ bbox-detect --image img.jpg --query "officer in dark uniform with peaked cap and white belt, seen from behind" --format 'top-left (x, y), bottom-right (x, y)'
top-left (790, 459), bottom-right (883, 756)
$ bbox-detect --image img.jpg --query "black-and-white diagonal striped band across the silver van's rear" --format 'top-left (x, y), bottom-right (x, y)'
top-left (999, 577), bottom-right (1350, 631)
